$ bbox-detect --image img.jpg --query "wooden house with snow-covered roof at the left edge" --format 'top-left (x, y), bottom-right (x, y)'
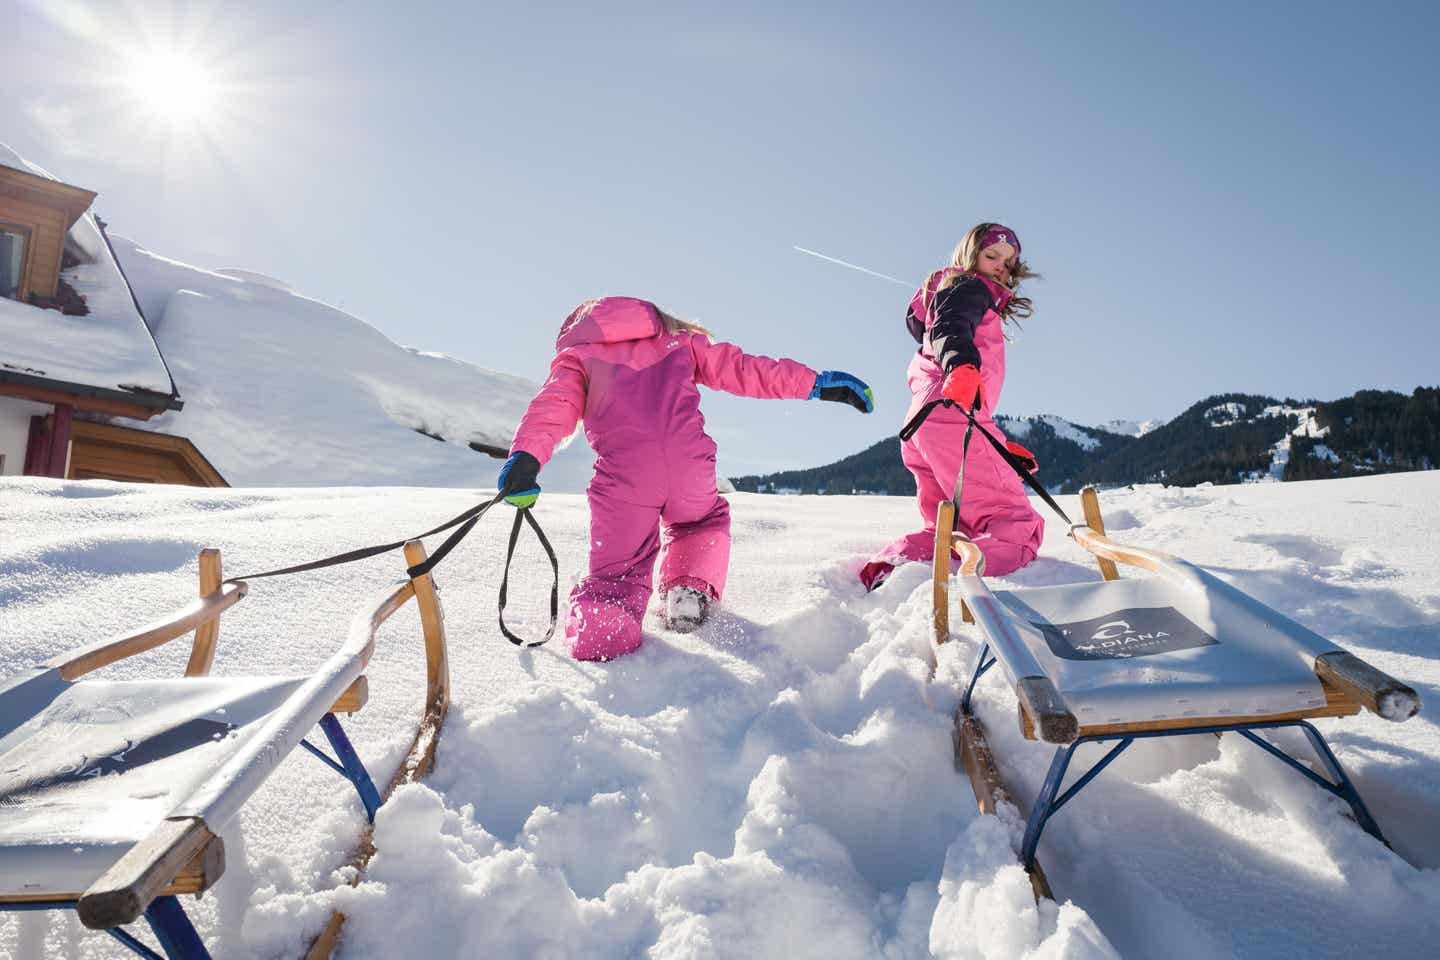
top-left (0, 161), bottom-right (226, 486)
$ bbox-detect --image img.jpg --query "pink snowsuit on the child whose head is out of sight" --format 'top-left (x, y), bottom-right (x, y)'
top-left (510, 296), bottom-right (815, 659)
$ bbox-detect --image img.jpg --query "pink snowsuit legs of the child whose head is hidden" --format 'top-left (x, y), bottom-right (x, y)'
top-left (566, 469), bottom-right (730, 661)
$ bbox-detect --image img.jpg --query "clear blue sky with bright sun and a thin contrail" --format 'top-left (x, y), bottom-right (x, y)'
top-left (0, 0), bottom-right (1440, 475)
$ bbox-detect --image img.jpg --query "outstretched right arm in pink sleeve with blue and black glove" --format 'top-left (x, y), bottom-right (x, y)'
top-left (690, 334), bottom-right (876, 413)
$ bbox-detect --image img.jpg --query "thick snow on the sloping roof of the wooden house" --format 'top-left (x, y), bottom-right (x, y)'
top-left (0, 144), bottom-right (179, 409)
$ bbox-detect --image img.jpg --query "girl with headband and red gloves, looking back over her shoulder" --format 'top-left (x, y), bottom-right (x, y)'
top-left (860, 223), bottom-right (1045, 590)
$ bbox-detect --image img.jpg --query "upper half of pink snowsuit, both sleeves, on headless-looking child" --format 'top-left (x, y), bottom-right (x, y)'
top-left (510, 296), bottom-right (815, 504)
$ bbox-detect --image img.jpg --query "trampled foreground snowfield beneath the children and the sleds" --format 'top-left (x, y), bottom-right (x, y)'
top-left (0, 474), bottom-right (1440, 960)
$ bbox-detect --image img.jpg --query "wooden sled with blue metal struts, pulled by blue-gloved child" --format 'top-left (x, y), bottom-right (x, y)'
top-left (0, 541), bottom-right (449, 960)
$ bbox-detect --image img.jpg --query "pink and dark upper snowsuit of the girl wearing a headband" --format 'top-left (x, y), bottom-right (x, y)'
top-left (906, 266), bottom-right (1014, 420)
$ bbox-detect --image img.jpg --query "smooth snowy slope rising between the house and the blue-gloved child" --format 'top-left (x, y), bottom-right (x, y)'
top-left (111, 236), bottom-right (590, 491)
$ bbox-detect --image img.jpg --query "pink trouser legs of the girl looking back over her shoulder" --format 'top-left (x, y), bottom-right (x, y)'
top-left (876, 407), bottom-right (1045, 577)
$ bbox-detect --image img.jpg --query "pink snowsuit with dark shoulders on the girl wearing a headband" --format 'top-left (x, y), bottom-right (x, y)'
top-left (874, 268), bottom-right (1045, 576)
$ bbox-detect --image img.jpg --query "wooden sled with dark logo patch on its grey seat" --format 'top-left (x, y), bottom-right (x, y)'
top-left (935, 488), bottom-right (1420, 897)
